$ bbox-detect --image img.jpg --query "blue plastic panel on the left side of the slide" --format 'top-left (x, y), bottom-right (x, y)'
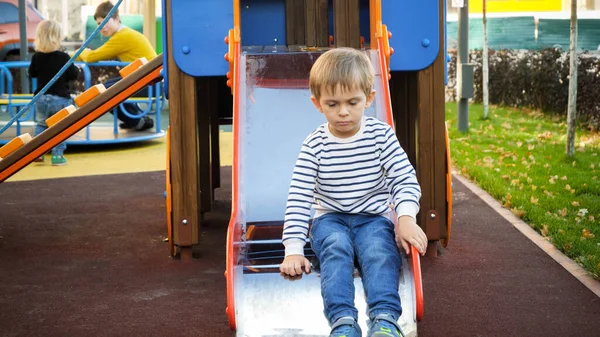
top-left (169, 0), bottom-right (233, 76)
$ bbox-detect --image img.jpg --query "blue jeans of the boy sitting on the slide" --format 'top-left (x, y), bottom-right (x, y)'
top-left (309, 213), bottom-right (402, 324)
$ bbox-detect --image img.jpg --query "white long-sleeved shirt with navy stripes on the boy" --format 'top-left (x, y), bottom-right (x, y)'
top-left (282, 117), bottom-right (421, 256)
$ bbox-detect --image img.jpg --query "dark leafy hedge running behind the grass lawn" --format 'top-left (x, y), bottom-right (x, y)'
top-left (446, 48), bottom-right (600, 130)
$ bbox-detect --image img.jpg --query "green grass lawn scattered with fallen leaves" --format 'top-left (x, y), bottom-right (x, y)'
top-left (446, 103), bottom-right (600, 279)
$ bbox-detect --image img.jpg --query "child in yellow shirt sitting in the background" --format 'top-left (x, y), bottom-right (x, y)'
top-left (77, 1), bottom-right (156, 131)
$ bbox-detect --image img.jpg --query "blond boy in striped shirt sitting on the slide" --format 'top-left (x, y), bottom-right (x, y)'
top-left (280, 48), bottom-right (427, 337)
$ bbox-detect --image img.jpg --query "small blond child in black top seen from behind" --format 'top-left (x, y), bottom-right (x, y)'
top-left (29, 20), bottom-right (79, 166)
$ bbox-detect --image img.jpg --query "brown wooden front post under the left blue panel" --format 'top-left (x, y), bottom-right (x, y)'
top-left (164, 0), bottom-right (201, 252)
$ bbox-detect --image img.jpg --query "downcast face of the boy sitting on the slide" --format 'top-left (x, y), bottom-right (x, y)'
top-left (311, 85), bottom-right (375, 138)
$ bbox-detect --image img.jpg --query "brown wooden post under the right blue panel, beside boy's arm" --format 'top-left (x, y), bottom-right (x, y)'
top-left (390, 0), bottom-right (448, 256)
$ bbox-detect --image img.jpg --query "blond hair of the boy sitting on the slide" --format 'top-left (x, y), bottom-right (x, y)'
top-left (309, 48), bottom-right (375, 99)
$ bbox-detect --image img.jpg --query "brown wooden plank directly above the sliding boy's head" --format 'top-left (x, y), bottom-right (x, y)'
top-left (333, 0), bottom-right (360, 48)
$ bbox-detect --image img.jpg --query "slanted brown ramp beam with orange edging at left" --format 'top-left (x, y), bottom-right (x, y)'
top-left (0, 55), bottom-right (162, 183)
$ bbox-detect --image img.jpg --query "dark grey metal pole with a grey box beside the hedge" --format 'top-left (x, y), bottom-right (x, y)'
top-left (456, 0), bottom-right (469, 132)
